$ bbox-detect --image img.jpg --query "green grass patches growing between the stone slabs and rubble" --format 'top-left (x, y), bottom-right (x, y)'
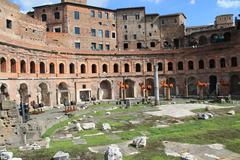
top-left (13, 102), bottom-right (240, 160)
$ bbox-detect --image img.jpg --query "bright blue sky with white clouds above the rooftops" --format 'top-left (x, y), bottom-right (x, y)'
top-left (11, 0), bottom-right (240, 26)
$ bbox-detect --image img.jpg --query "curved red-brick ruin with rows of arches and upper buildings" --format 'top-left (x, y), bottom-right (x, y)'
top-left (0, 0), bottom-right (240, 106)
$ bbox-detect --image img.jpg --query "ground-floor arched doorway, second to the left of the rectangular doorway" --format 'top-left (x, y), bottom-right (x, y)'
top-left (39, 83), bottom-right (50, 106)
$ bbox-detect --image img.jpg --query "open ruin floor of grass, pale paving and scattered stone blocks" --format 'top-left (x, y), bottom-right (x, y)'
top-left (6, 99), bottom-right (240, 160)
